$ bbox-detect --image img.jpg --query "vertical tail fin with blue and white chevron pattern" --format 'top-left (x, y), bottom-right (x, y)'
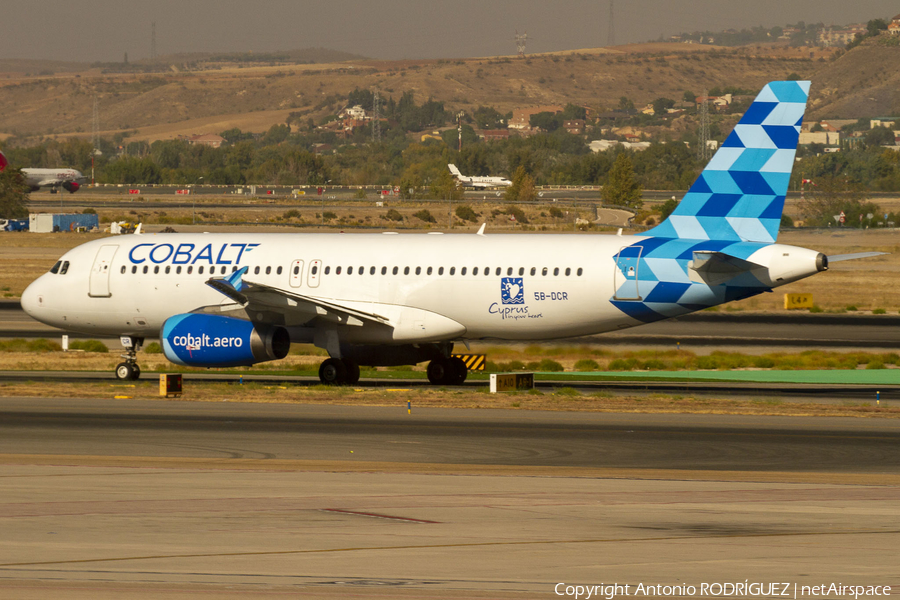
top-left (644, 81), bottom-right (810, 243)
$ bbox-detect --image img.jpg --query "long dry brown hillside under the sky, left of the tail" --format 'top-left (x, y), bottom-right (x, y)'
top-left (0, 44), bottom-right (852, 141)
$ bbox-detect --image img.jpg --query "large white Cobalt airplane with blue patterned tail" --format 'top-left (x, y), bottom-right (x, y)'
top-left (21, 81), bottom-right (881, 385)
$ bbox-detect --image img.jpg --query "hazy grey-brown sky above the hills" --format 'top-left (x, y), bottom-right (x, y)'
top-left (0, 0), bottom-right (900, 62)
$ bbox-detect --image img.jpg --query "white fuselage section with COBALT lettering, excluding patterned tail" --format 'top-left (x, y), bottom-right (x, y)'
top-left (22, 233), bottom-right (641, 343)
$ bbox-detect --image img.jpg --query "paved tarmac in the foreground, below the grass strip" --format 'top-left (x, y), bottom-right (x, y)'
top-left (0, 398), bottom-right (900, 598)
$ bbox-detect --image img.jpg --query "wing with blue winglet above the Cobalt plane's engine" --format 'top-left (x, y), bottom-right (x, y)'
top-left (206, 267), bottom-right (390, 326)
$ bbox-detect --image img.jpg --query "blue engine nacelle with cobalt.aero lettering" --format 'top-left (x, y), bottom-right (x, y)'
top-left (160, 313), bottom-right (291, 367)
